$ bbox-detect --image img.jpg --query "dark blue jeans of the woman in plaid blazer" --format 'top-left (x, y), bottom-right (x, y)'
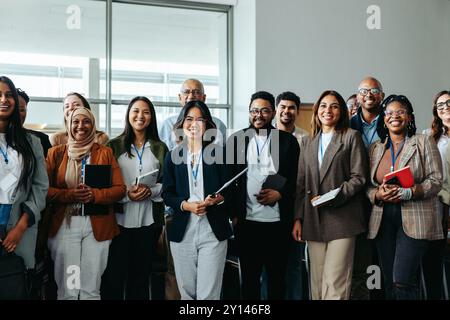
top-left (376, 203), bottom-right (429, 300)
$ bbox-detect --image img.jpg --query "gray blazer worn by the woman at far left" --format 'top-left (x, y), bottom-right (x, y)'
top-left (7, 133), bottom-right (48, 268)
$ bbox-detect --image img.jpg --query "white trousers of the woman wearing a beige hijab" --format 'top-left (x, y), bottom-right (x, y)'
top-left (48, 216), bottom-right (111, 300)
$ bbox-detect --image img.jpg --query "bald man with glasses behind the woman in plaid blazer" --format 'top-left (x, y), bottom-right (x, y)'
top-left (350, 77), bottom-right (384, 300)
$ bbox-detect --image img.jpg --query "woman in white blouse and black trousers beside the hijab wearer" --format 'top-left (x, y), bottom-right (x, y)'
top-left (102, 97), bottom-right (168, 300)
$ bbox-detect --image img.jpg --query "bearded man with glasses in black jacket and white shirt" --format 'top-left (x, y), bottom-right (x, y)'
top-left (227, 91), bottom-right (299, 300)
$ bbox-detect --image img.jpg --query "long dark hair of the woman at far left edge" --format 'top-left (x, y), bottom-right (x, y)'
top-left (0, 76), bottom-right (36, 187)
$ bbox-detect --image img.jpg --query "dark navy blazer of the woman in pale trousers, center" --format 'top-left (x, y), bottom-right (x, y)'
top-left (162, 144), bottom-right (233, 242)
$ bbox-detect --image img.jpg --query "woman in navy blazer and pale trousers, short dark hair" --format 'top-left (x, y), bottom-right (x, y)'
top-left (163, 101), bottom-right (232, 300)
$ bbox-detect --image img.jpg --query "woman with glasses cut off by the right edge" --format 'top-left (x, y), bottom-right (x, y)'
top-left (422, 91), bottom-right (450, 300)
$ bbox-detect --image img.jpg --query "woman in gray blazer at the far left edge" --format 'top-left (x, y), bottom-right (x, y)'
top-left (0, 76), bottom-right (48, 269)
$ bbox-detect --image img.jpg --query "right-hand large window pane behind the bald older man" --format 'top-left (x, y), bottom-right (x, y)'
top-left (112, 3), bottom-right (227, 104)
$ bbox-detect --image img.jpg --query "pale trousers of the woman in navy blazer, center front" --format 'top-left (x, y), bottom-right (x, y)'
top-left (170, 213), bottom-right (228, 300)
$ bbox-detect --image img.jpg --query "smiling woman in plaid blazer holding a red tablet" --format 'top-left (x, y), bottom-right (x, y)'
top-left (367, 95), bottom-right (443, 300)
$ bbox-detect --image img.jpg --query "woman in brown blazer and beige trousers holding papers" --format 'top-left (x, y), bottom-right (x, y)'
top-left (292, 91), bottom-right (368, 300)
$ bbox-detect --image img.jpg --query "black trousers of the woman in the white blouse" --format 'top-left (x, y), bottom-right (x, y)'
top-left (101, 224), bottom-right (156, 300)
